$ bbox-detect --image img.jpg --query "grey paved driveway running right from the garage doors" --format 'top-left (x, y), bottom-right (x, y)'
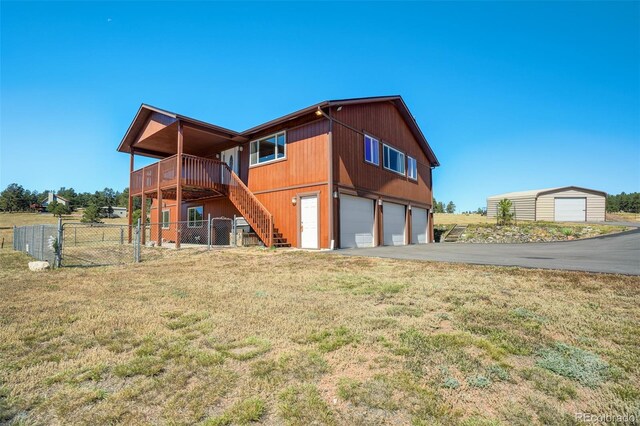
top-left (335, 228), bottom-right (640, 275)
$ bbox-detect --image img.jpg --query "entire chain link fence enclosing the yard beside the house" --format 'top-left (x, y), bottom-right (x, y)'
top-left (13, 217), bottom-right (237, 266)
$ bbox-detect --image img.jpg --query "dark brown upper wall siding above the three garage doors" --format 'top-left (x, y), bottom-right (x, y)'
top-left (332, 103), bottom-right (431, 207)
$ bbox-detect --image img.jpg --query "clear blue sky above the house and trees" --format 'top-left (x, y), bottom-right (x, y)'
top-left (0, 1), bottom-right (640, 210)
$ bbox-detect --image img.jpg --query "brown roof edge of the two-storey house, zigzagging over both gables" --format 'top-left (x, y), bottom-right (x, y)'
top-left (118, 95), bottom-right (440, 167)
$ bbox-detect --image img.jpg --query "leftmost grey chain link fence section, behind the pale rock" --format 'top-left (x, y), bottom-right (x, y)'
top-left (13, 225), bottom-right (58, 265)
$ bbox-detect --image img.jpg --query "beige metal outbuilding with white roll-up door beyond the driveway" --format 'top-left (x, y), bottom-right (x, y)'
top-left (487, 186), bottom-right (607, 222)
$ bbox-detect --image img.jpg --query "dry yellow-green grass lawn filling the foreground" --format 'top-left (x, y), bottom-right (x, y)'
top-left (0, 248), bottom-right (640, 425)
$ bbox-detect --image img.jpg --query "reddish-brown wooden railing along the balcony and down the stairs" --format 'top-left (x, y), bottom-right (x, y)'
top-left (130, 154), bottom-right (273, 247)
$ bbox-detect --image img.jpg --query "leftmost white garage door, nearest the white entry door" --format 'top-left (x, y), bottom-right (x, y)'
top-left (340, 195), bottom-right (373, 248)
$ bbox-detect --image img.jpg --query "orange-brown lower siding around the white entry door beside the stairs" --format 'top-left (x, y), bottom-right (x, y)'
top-left (256, 185), bottom-right (329, 248)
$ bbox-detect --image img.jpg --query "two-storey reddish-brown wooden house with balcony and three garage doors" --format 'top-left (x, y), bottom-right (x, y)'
top-left (118, 96), bottom-right (439, 249)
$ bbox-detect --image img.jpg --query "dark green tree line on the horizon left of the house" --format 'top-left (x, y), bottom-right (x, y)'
top-left (0, 183), bottom-right (134, 218)
